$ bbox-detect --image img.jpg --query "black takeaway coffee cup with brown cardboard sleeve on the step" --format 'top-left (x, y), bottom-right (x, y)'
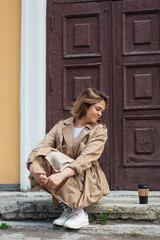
top-left (138, 184), bottom-right (149, 204)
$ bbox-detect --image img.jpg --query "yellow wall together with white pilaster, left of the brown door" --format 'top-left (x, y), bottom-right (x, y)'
top-left (0, 0), bottom-right (46, 190)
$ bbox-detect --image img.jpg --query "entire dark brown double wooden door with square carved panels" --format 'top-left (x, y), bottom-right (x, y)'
top-left (46, 0), bottom-right (160, 190)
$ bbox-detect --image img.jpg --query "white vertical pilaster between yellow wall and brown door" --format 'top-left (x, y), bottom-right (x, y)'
top-left (20, 0), bottom-right (46, 191)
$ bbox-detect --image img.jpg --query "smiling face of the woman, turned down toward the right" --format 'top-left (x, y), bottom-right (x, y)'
top-left (85, 100), bottom-right (106, 123)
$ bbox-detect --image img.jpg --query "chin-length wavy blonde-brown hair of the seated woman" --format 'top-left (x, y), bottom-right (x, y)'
top-left (71, 88), bottom-right (109, 119)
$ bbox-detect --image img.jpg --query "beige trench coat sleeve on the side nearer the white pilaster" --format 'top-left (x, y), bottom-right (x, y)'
top-left (26, 124), bottom-right (58, 168)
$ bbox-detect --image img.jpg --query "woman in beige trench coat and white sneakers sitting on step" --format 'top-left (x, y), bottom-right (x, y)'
top-left (27, 88), bottom-right (109, 229)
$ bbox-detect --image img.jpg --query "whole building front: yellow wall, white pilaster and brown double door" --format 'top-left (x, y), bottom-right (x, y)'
top-left (0, 0), bottom-right (160, 190)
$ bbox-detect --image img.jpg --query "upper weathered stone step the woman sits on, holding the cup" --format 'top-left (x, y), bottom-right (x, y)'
top-left (0, 191), bottom-right (160, 222)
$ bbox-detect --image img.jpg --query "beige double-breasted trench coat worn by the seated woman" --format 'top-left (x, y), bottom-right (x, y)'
top-left (27, 117), bottom-right (109, 208)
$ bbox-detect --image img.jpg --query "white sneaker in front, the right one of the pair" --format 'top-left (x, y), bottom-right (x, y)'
top-left (64, 211), bottom-right (89, 229)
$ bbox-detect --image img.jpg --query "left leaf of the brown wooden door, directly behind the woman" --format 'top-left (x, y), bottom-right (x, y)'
top-left (46, 0), bottom-right (112, 186)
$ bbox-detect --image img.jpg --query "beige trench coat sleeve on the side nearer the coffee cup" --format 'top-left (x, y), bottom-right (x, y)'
top-left (70, 124), bottom-right (108, 174)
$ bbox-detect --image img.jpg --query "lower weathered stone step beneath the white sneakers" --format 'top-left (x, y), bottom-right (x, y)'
top-left (0, 220), bottom-right (160, 240)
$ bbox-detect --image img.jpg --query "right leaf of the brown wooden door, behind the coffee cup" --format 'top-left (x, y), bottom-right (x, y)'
top-left (112, 0), bottom-right (160, 190)
